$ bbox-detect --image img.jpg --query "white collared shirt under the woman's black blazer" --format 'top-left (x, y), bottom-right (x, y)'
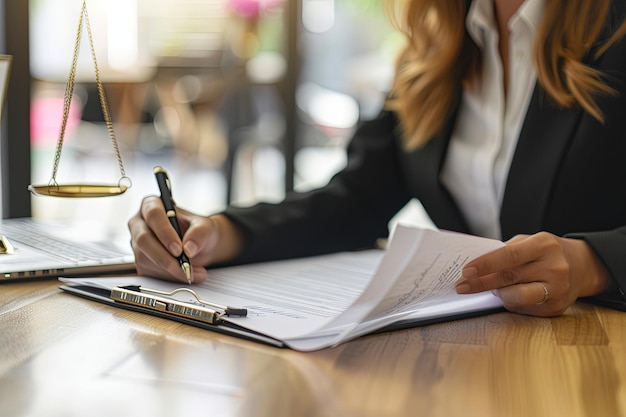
top-left (441, 0), bottom-right (544, 239)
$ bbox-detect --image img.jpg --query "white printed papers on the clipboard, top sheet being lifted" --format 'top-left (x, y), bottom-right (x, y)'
top-left (61, 226), bottom-right (503, 351)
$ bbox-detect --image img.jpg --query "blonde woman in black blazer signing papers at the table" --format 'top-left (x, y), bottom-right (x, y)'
top-left (129, 0), bottom-right (626, 316)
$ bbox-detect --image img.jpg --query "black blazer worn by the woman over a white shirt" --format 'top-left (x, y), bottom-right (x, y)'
top-left (225, 0), bottom-right (626, 308)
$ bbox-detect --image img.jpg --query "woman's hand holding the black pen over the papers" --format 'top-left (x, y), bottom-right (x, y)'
top-left (128, 196), bottom-right (243, 283)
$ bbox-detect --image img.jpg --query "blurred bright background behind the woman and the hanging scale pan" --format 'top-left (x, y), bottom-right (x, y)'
top-left (2, 0), bottom-right (410, 234)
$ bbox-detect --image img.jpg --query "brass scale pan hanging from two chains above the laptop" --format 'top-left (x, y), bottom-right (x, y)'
top-left (28, 0), bottom-right (132, 198)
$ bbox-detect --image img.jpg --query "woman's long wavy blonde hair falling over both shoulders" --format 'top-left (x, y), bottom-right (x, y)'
top-left (385, 0), bottom-right (626, 149)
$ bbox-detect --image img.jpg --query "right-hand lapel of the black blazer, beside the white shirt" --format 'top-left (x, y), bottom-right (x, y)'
top-left (500, 85), bottom-right (582, 240)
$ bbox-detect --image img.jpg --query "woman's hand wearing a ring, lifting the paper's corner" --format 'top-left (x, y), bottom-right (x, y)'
top-left (456, 232), bottom-right (611, 317)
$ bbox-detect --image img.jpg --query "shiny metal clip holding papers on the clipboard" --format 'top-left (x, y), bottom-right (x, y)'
top-left (111, 285), bottom-right (248, 324)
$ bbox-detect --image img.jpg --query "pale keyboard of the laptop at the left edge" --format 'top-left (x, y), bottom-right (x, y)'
top-left (2, 222), bottom-right (128, 262)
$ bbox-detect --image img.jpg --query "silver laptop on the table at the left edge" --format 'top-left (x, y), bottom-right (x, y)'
top-left (0, 217), bottom-right (135, 282)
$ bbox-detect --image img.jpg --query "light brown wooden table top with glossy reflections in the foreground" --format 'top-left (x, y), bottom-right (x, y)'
top-left (0, 281), bottom-right (626, 417)
